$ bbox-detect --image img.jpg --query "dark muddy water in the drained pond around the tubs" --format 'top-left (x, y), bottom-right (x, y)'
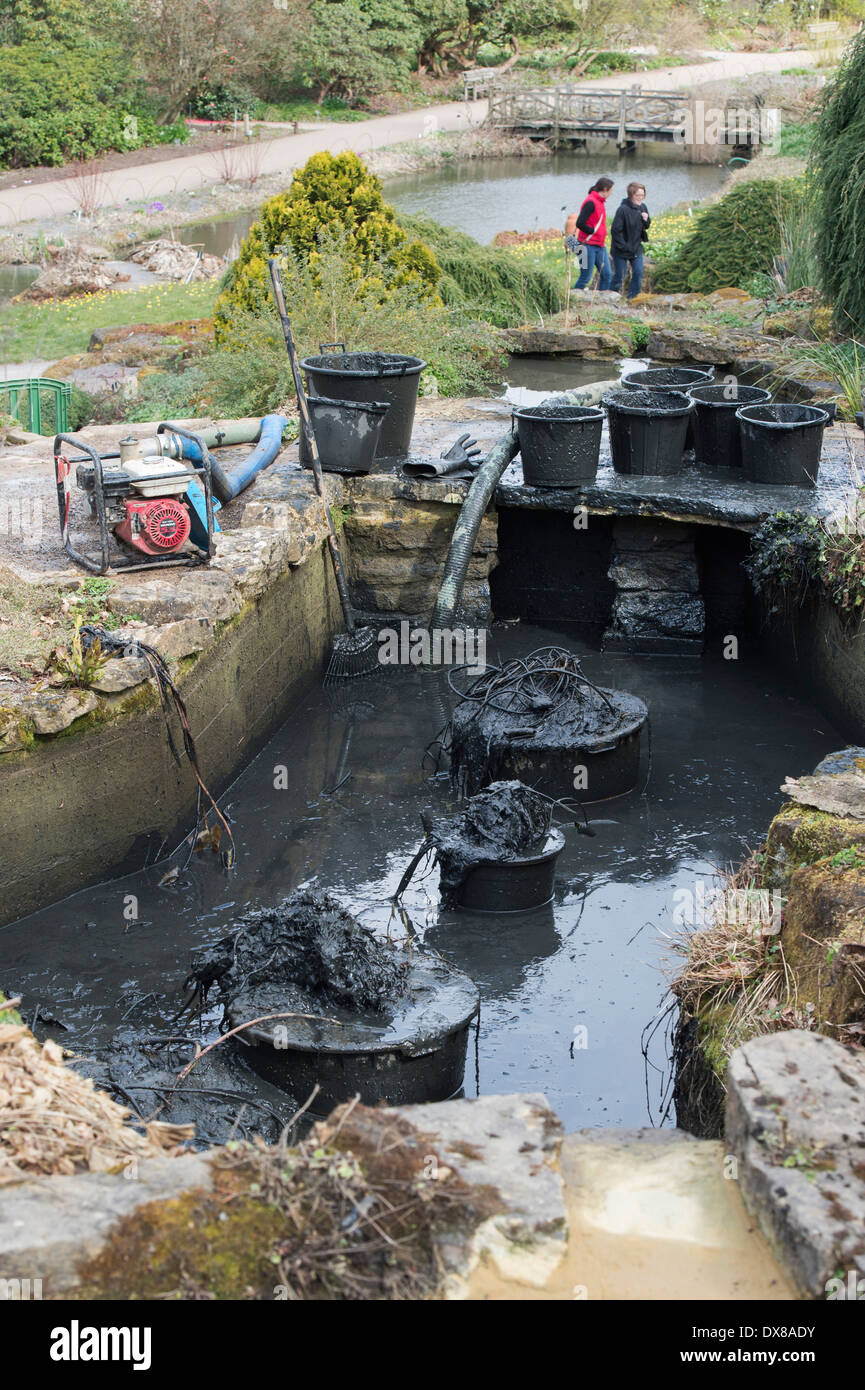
top-left (0, 624), bottom-right (844, 1137)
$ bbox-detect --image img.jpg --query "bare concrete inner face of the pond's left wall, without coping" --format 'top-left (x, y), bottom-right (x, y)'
top-left (0, 546), bottom-right (339, 924)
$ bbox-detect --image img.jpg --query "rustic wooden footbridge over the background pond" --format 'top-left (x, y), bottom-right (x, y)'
top-left (487, 82), bottom-right (765, 149)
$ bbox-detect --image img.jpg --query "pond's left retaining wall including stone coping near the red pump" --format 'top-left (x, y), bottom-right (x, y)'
top-left (0, 500), bottom-right (346, 923)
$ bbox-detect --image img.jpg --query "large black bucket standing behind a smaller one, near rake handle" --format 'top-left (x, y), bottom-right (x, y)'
top-left (300, 350), bottom-right (427, 459)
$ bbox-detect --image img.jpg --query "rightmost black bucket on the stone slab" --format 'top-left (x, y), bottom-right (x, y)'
top-left (736, 403), bottom-right (829, 488)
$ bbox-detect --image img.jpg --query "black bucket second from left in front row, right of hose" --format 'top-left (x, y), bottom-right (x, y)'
top-left (604, 391), bottom-right (694, 477)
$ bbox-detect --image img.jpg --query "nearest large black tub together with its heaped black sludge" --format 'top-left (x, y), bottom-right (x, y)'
top-left (185, 887), bottom-right (478, 1115)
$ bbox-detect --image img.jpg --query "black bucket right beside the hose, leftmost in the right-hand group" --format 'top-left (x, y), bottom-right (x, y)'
top-left (513, 402), bottom-right (604, 488)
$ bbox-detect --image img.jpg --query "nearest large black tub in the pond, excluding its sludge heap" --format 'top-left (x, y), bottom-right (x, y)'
top-left (228, 951), bottom-right (480, 1115)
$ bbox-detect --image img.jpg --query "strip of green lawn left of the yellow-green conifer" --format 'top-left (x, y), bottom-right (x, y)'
top-left (0, 278), bottom-right (220, 363)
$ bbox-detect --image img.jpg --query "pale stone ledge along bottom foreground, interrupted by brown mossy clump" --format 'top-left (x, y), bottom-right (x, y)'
top-left (0, 1095), bottom-right (567, 1298)
